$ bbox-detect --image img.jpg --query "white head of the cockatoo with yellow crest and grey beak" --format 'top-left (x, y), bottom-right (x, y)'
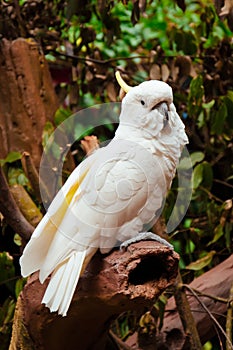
top-left (116, 72), bottom-right (186, 138)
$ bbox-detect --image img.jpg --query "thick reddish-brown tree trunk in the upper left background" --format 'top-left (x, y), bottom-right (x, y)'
top-left (0, 38), bottom-right (58, 168)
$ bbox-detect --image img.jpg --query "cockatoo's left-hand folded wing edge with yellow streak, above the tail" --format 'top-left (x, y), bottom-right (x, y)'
top-left (20, 167), bottom-right (89, 277)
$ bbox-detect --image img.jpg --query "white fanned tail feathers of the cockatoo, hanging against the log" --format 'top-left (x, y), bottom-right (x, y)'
top-left (42, 251), bottom-right (86, 316)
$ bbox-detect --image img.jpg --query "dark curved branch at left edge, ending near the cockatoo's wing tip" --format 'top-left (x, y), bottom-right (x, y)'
top-left (0, 167), bottom-right (34, 241)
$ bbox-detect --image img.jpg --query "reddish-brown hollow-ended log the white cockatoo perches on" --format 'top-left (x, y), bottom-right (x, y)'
top-left (10, 241), bottom-right (179, 350)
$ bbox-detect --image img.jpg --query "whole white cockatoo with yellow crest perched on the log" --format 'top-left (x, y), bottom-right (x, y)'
top-left (20, 73), bottom-right (188, 316)
